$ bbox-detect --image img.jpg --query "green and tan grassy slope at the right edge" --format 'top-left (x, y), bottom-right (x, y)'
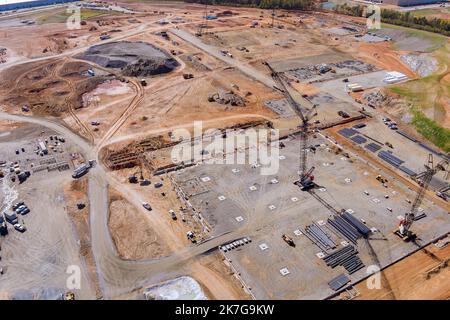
top-left (389, 45), bottom-right (450, 152)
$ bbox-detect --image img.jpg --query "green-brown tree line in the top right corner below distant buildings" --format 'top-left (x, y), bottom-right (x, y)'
top-left (334, 4), bottom-right (450, 36)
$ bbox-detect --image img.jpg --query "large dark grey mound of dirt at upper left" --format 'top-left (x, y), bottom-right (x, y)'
top-left (77, 41), bottom-right (179, 77)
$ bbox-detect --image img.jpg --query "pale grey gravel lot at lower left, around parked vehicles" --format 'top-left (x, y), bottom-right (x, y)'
top-left (0, 125), bottom-right (95, 299)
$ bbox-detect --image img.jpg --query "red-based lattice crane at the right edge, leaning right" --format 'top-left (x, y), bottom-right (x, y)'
top-left (394, 154), bottom-right (449, 241)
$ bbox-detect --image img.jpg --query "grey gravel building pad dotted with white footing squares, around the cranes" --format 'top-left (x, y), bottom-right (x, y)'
top-left (171, 133), bottom-right (450, 299)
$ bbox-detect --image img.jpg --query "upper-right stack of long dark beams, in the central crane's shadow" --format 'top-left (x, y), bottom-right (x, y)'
top-left (328, 212), bottom-right (371, 244)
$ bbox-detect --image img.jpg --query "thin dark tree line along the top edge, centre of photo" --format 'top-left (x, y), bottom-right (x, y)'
top-left (184, 0), bottom-right (315, 10)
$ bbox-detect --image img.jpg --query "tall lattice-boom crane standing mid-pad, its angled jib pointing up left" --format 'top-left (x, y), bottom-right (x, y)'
top-left (264, 62), bottom-right (317, 191)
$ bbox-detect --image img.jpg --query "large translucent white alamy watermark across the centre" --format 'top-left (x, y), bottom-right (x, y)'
top-left (171, 121), bottom-right (280, 175)
